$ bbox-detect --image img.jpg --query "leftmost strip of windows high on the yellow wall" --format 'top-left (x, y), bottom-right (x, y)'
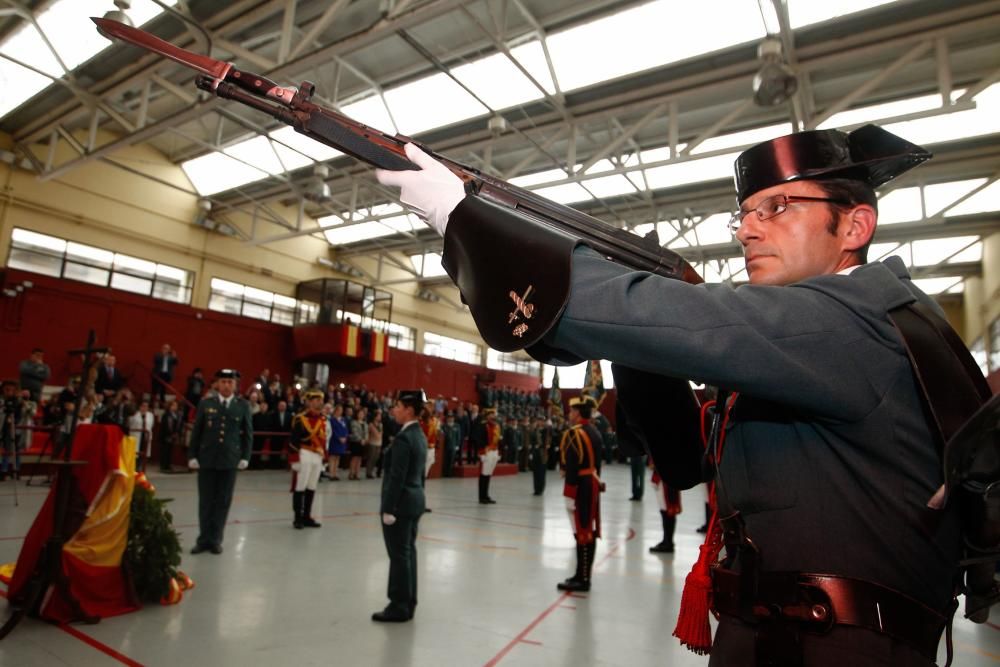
top-left (7, 228), bottom-right (194, 303)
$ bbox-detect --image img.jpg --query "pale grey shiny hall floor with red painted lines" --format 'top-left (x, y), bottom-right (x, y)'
top-left (0, 465), bottom-right (1000, 667)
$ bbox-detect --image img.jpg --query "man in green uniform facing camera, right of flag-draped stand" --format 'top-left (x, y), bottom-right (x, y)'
top-left (188, 368), bottom-right (253, 554)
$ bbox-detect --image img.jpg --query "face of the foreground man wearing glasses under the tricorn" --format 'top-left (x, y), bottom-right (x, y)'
top-left (736, 181), bottom-right (862, 285)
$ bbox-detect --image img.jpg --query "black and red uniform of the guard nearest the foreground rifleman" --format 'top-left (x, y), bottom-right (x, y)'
top-left (559, 419), bottom-right (601, 590)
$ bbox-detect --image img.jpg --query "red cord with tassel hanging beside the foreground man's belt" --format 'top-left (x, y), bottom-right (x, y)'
top-left (673, 394), bottom-right (736, 655)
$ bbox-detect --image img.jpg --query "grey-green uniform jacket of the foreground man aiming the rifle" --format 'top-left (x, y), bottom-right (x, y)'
top-left (545, 248), bottom-right (959, 610)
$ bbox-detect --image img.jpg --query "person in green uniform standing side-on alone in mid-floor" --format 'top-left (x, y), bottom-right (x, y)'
top-left (372, 389), bottom-right (427, 623)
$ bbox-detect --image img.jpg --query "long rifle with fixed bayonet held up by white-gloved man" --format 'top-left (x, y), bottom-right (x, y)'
top-left (92, 18), bottom-right (702, 283)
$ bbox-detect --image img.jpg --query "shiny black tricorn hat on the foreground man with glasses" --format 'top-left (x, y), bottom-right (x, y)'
top-left (735, 125), bottom-right (933, 202)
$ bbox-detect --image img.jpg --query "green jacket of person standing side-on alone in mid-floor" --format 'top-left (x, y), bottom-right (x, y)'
top-left (379, 422), bottom-right (427, 518)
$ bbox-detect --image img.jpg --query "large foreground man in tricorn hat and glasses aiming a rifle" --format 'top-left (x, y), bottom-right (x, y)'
top-left (379, 125), bottom-right (961, 666)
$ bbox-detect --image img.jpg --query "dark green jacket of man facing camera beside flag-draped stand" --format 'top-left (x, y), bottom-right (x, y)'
top-left (188, 396), bottom-right (253, 470)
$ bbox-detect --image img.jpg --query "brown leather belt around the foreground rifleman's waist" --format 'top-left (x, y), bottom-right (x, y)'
top-left (712, 567), bottom-right (948, 661)
